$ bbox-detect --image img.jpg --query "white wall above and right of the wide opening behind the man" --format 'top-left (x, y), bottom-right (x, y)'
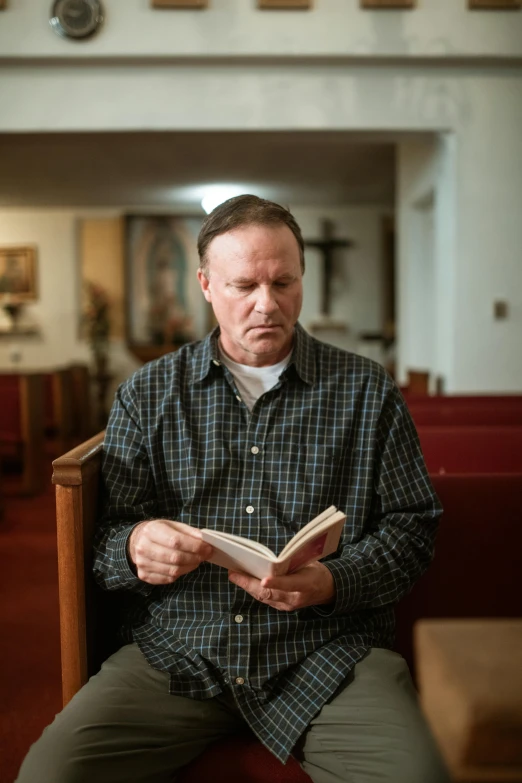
top-left (0, 0), bottom-right (522, 392)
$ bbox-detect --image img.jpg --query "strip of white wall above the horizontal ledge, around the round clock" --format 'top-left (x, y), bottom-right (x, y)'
top-left (0, 0), bottom-right (522, 60)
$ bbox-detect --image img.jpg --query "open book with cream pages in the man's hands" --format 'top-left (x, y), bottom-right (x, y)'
top-left (201, 506), bottom-right (346, 579)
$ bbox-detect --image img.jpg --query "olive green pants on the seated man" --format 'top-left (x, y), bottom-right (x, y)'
top-left (18, 644), bottom-right (449, 783)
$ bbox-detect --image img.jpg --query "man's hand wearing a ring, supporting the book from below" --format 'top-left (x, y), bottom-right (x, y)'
top-left (228, 561), bottom-right (335, 612)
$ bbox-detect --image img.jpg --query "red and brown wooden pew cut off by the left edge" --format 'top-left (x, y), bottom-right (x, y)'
top-left (0, 372), bottom-right (48, 495)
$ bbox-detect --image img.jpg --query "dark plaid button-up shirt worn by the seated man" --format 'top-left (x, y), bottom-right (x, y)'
top-left (94, 324), bottom-right (441, 761)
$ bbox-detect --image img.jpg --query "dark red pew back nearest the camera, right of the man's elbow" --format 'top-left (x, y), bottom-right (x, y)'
top-left (396, 473), bottom-right (522, 671)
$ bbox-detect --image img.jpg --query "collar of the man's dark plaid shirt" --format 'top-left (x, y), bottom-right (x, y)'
top-left (193, 323), bottom-right (315, 385)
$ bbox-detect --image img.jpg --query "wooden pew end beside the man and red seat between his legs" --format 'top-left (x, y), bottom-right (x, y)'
top-left (52, 432), bottom-right (311, 783)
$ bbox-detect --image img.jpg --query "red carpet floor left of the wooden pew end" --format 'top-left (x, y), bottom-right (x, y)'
top-left (0, 472), bottom-right (61, 783)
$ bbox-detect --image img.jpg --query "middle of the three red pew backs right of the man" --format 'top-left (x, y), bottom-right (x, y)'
top-left (417, 426), bottom-right (522, 474)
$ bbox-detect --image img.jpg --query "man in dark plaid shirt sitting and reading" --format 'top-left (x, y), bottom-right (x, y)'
top-left (19, 196), bottom-right (447, 783)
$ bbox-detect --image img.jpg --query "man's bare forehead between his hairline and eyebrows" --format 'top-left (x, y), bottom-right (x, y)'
top-left (207, 224), bottom-right (300, 271)
